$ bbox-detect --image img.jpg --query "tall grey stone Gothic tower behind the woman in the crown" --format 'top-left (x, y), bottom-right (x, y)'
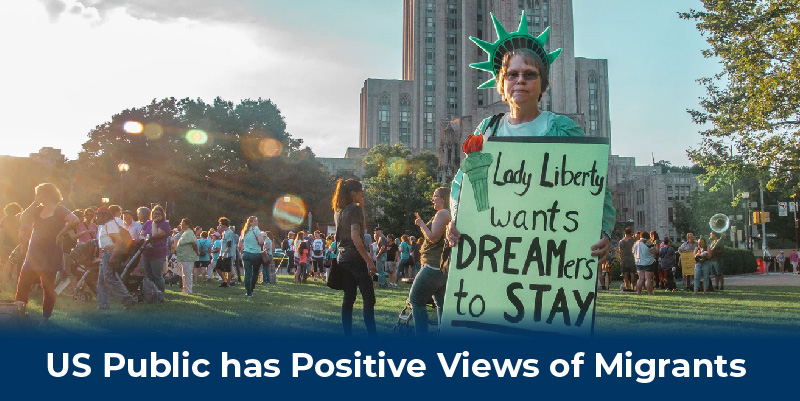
top-left (359, 0), bottom-right (611, 181)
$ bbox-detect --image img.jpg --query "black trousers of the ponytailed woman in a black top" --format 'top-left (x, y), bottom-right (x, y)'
top-left (339, 260), bottom-right (378, 337)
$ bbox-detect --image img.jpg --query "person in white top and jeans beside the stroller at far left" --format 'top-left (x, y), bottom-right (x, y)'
top-left (95, 206), bottom-right (136, 310)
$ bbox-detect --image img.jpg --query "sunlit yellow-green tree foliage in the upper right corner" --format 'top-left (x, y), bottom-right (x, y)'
top-left (679, 0), bottom-right (800, 192)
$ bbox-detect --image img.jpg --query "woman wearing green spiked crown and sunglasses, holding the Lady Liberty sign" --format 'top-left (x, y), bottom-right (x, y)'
top-left (447, 11), bottom-right (616, 263)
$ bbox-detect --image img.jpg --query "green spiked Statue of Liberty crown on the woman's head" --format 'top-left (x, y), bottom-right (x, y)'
top-left (469, 10), bottom-right (561, 89)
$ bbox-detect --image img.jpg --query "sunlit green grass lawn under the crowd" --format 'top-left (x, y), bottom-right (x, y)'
top-left (0, 275), bottom-right (800, 336)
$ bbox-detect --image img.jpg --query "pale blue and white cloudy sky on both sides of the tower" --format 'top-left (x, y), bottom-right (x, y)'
top-left (0, 0), bottom-right (720, 165)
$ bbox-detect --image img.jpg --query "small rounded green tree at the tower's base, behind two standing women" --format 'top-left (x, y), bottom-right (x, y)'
top-left (364, 144), bottom-right (440, 235)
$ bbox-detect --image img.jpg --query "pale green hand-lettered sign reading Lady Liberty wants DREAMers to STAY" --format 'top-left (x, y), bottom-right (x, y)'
top-left (440, 137), bottom-right (609, 336)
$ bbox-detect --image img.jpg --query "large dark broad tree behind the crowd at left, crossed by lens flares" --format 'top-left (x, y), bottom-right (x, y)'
top-left (71, 98), bottom-right (333, 229)
